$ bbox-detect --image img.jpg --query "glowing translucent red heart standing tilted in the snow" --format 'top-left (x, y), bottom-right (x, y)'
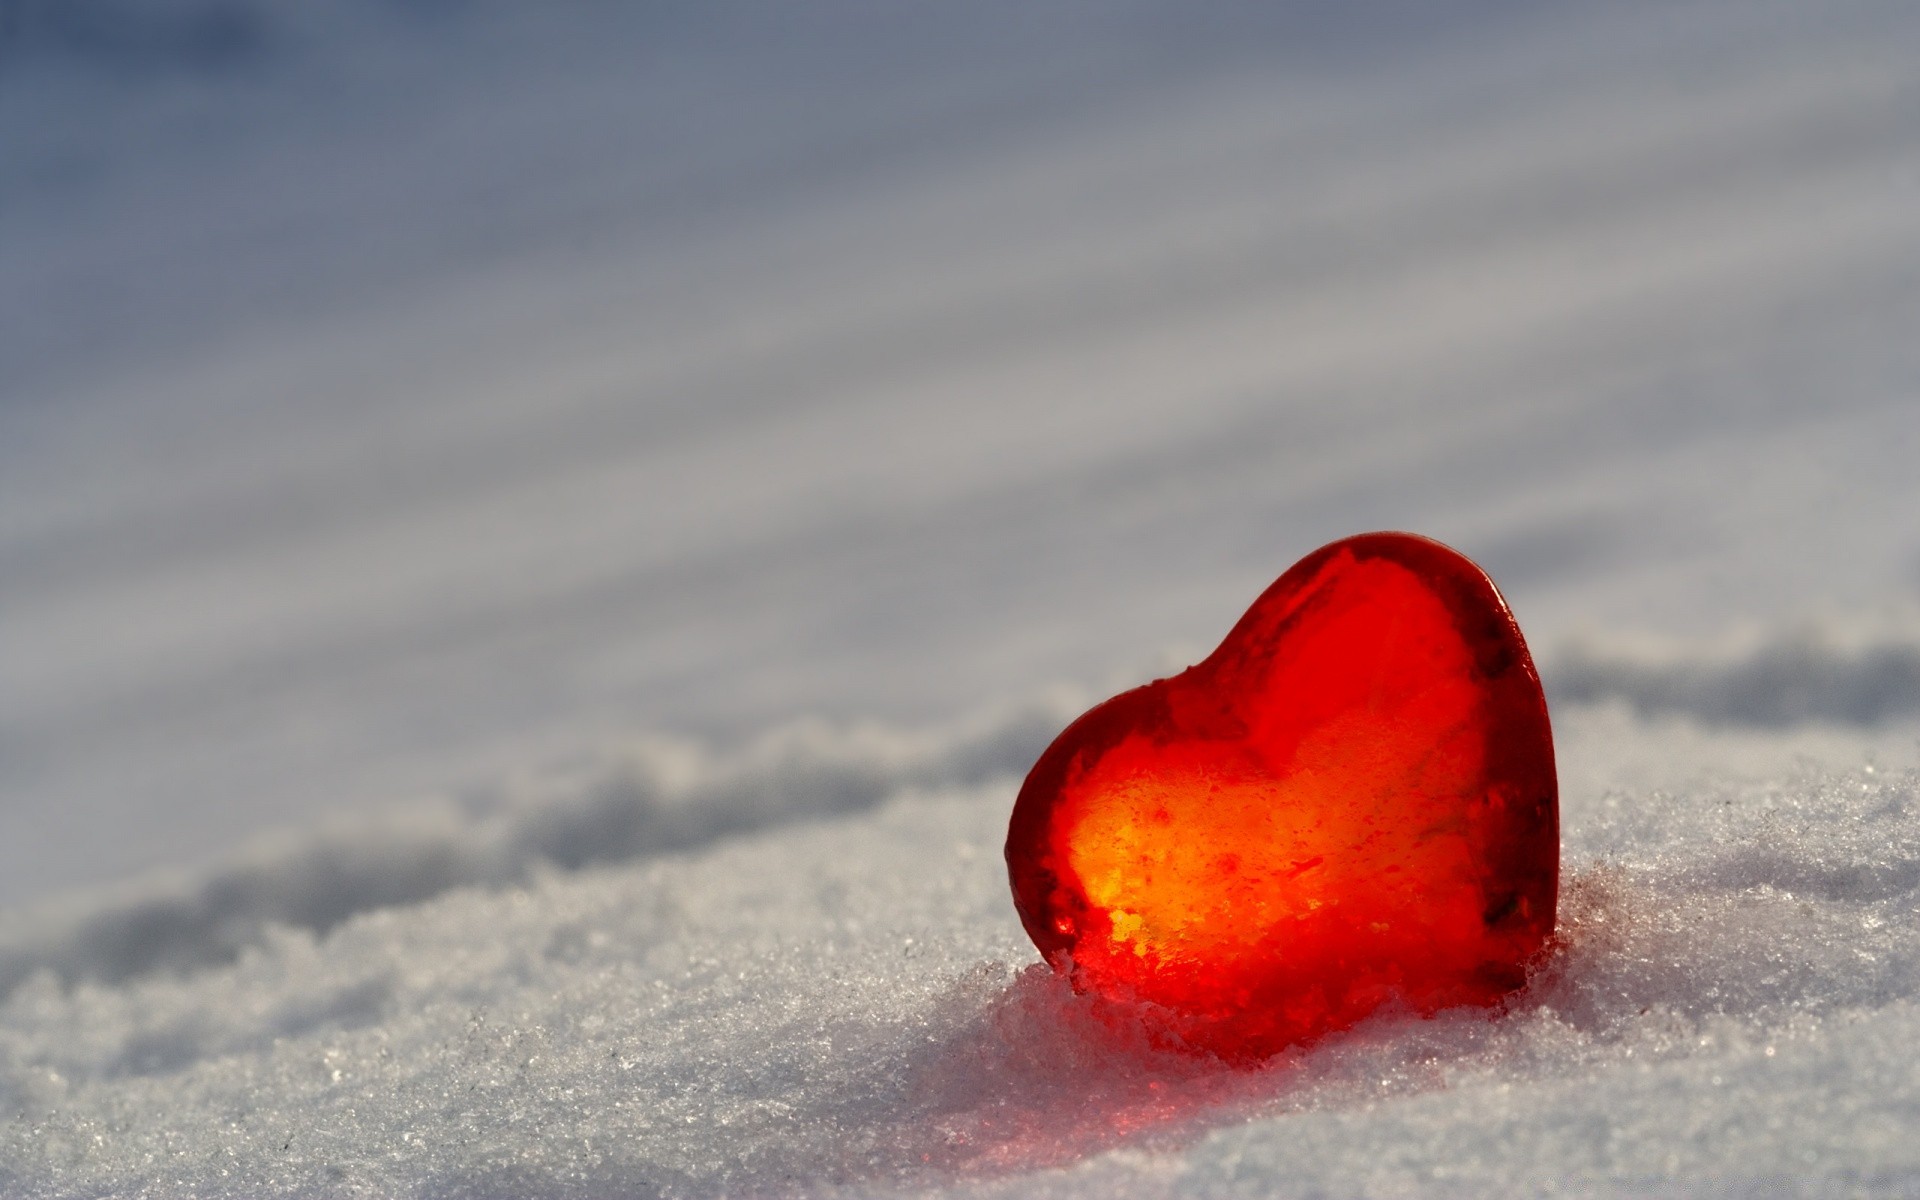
top-left (1006, 534), bottom-right (1559, 1062)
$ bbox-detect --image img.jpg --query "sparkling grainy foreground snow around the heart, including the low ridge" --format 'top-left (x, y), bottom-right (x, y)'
top-left (0, 707), bottom-right (1920, 1196)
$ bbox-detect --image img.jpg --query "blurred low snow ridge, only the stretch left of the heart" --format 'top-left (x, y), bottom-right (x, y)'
top-left (0, 699), bottom-right (1071, 995)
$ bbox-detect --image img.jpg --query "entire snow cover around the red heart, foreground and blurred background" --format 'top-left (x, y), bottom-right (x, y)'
top-left (0, 0), bottom-right (1920, 1200)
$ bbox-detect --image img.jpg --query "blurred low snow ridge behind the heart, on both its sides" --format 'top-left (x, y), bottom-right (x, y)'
top-left (0, 628), bottom-right (1920, 996)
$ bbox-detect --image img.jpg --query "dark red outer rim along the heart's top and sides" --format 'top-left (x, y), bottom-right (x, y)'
top-left (1006, 532), bottom-right (1559, 970)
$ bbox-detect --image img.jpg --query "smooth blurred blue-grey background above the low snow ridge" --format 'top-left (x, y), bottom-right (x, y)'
top-left (0, 0), bottom-right (1920, 904)
